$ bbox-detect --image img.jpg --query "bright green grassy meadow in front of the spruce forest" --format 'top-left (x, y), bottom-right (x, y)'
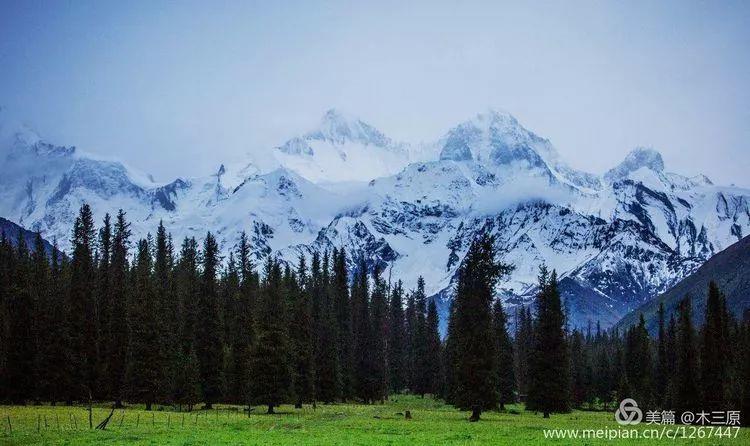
top-left (0, 396), bottom-right (750, 446)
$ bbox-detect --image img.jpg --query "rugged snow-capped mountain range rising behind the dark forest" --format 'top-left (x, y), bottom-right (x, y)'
top-left (0, 111), bottom-right (750, 327)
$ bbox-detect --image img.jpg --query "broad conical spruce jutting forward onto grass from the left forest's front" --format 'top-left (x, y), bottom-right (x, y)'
top-left (250, 257), bottom-right (293, 414)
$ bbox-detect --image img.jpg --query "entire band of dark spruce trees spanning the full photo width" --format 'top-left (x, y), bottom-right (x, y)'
top-left (0, 205), bottom-right (750, 421)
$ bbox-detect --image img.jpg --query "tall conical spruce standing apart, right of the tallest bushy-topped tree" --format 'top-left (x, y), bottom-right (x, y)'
top-left (527, 268), bottom-right (570, 418)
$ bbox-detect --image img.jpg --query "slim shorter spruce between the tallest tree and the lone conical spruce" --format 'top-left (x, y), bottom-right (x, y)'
top-left (492, 299), bottom-right (516, 410)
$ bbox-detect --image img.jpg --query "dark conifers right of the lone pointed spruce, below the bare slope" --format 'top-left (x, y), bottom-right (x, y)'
top-left (569, 282), bottom-right (750, 418)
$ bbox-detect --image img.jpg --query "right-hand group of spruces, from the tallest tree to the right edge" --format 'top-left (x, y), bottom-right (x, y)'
top-left (442, 235), bottom-right (750, 425)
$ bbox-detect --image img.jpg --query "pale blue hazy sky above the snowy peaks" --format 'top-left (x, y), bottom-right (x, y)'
top-left (0, 0), bottom-right (750, 187)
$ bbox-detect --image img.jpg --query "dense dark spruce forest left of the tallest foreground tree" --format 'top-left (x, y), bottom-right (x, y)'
top-left (0, 205), bottom-right (441, 412)
